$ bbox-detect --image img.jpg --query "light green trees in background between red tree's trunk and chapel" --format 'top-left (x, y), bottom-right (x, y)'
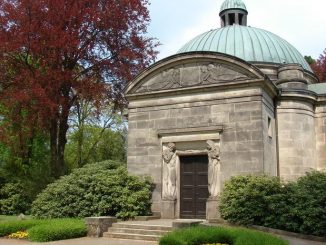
top-left (65, 98), bottom-right (126, 167)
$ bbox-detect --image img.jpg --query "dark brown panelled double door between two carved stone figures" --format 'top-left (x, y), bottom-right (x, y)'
top-left (180, 155), bottom-right (209, 219)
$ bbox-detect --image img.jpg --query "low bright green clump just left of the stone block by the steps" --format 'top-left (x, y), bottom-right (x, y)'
top-left (27, 219), bottom-right (87, 242)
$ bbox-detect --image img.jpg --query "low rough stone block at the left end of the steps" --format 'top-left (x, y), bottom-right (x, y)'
top-left (85, 216), bottom-right (117, 237)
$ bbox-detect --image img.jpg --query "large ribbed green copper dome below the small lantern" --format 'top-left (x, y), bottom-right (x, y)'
top-left (178, 25), bottom-right (312, 71)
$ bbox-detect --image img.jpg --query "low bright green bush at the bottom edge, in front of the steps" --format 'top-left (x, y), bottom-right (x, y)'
top-left (159, 227), bottom-right (288, 245)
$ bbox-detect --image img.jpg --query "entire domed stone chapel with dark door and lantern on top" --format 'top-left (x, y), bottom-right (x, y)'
top-left (125, 0), bottom-right (326, 219)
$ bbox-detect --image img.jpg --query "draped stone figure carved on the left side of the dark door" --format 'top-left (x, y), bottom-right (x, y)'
top-left (163, 143), bottom-right (177, 200)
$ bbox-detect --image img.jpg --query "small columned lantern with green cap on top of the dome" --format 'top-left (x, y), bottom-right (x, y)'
top-left (220, 0), bottom-right (248, 27)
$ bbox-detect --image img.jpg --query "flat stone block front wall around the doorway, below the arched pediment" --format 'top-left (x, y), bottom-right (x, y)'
top-left (128, 87), bottom-right (276, 214)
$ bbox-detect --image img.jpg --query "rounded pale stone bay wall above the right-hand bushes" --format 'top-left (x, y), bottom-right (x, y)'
top-left (277, 99), bottom-right (317, 180)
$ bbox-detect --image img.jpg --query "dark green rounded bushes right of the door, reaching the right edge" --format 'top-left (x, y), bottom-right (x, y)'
top-left (220, 171), bottom-right (326, 237)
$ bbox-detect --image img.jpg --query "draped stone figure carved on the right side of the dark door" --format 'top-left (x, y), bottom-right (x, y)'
top-left (206, 140), bottom-right (221, 198)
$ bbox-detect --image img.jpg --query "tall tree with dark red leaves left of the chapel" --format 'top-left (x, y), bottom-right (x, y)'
top-left (0, 0), bottom-right (157, 177)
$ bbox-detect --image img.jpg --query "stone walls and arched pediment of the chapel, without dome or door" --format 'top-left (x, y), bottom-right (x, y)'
top-left (126, 52), bottom-right (326, 219)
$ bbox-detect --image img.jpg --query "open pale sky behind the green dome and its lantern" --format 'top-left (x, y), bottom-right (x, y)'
top-left (148, 0), bottom-right (326, 59)
